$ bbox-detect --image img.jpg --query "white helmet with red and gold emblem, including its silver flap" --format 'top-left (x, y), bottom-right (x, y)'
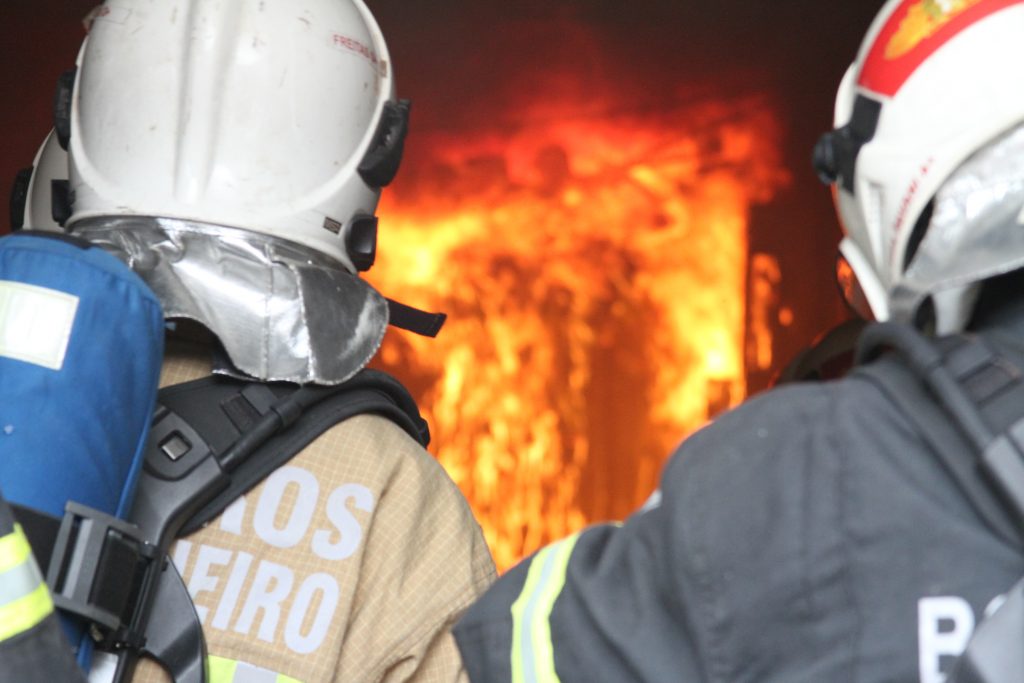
top-left (815, 0), bottom-right (1024, 333)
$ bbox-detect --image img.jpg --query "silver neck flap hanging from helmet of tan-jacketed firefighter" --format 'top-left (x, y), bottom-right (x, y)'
top-left (73, 216), bottom-right (388, 384)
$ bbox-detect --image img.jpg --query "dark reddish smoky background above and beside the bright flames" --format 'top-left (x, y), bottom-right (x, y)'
top-left (0, 0), bottom-right (882, 378)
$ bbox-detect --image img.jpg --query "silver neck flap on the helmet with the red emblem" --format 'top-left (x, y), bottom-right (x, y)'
top-left (893, 125), bottom-right (1024, 315)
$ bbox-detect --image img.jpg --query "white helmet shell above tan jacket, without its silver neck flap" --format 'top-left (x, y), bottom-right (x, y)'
top-left (56, 0), bottom-right (408, 272)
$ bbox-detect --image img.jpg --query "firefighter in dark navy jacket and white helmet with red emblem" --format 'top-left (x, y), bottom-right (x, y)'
top-left (455, 0), bottom-right (1024, 683)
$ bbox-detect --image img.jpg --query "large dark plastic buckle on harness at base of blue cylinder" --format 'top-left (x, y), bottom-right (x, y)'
top-left (46, 502), bottom-right (162, 649)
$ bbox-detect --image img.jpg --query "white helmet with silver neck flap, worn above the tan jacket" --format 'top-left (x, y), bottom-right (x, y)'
top-left (35, 0), bottom-right (443, 384)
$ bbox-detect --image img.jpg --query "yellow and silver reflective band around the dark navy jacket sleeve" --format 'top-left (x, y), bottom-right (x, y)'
top-left (512, 533), bottom-right (580, 683)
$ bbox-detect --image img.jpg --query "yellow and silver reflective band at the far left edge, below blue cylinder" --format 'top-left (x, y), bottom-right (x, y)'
top-left (0, 524), bottom-right (53, 641)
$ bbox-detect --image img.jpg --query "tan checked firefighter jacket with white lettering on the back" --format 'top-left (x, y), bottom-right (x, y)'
top-left (133, 342), bottom-right (495, 683)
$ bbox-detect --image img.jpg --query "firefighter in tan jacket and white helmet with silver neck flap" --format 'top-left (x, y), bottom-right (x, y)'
top-left (39, 0), bottom-right (495, 683)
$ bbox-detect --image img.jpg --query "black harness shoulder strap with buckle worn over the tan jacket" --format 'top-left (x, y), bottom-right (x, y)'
top-left (17, 370), bottom-right (430, 683)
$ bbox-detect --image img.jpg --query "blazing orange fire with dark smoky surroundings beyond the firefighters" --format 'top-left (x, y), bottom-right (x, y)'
top-left (0, 0), bottom-right (877, 567)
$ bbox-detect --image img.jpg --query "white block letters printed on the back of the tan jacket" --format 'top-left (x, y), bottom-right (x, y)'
top-left (173, 466), bottom-right (376, 654)
